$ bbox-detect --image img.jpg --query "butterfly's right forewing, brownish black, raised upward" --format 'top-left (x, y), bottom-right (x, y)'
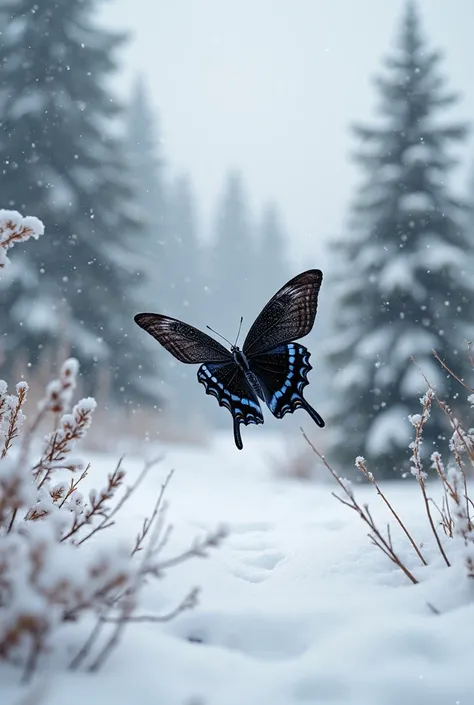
top-left (243, 269), bottom-right (323, 357)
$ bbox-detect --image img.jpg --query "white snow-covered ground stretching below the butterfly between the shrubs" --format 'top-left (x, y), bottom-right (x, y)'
top-left (0, 434), bottom-right (474, 705)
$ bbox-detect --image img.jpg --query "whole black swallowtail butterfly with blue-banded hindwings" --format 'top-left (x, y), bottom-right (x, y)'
top-left (135, 269), bottom-right (324, 450)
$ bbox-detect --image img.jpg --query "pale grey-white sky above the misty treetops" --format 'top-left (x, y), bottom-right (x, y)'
top-left (101, 0), bottom-right (474, 266)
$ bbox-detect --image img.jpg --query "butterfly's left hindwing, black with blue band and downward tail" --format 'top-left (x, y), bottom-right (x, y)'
top-left (197, 362), bottom-right (263, 450)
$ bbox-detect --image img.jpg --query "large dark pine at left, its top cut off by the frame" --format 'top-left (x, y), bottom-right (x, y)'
top-left (0, 0), bottom-right (156, 401)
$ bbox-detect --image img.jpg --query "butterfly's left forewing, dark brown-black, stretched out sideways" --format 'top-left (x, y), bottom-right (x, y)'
top-left (135, 313), bottom-right (232, 364)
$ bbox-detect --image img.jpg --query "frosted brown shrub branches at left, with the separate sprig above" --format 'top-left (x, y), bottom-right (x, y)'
top-left (0, 211), bottom-right (224, 676)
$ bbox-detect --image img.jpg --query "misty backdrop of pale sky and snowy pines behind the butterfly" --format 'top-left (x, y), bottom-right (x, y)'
top-left (0, 0), bottom-right (474, 474)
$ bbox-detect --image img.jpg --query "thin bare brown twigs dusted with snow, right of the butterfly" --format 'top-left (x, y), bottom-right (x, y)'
top-left (303, 352), bottom-right (474, 583)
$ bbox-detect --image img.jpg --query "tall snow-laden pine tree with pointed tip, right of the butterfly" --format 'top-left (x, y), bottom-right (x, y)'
top-left (330, 3), bottom-right (473, 477)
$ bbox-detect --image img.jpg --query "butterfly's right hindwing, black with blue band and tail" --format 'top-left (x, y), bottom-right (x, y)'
top-left (249, 343), bottom-right (325, 428)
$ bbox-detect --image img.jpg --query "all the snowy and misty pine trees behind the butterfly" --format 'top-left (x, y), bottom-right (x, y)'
top-left (0, 0), bottom-right (474, 472)
